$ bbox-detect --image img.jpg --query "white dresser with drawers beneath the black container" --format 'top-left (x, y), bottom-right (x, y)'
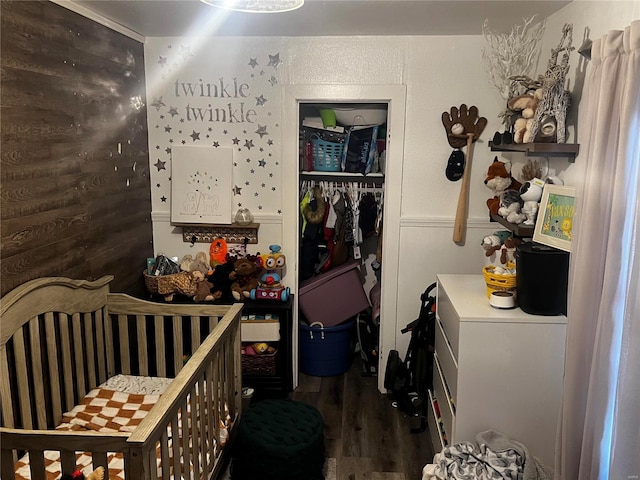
top-left (428, 275), bottom-right (567, 467)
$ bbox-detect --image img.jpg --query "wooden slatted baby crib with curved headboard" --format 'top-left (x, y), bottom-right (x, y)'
top-left (0, 276), bottom-right (242, 480)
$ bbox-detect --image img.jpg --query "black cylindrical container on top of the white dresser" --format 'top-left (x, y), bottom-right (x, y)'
top-left (516, 242), bottom-right (569, 315)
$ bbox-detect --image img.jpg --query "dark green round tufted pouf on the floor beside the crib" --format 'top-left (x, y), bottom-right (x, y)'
top-left (231, 399), bottom-right (325, 480)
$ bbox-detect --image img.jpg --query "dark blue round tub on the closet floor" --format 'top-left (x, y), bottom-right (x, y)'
top-left (298, 321), bottom-right (355, 377)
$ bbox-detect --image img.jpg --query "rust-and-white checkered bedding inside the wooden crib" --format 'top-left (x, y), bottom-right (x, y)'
top-left (16, 375), bottom-right (226, 480)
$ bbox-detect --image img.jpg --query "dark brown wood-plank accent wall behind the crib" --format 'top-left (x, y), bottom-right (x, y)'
top-left (0, 0), bottom-right (153, 295)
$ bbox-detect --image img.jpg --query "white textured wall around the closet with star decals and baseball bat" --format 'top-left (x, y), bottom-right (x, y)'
top-left (145, 0), bottom-right (638, 370)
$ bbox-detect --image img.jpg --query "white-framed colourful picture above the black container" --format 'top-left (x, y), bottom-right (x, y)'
top-left (533, 183), bottom-right (576, 252)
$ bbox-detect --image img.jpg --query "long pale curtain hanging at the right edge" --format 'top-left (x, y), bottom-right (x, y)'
top-left (555, 21), bottom-right (640, 480)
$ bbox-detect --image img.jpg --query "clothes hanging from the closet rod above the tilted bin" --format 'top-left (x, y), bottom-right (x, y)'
top-left (299, 181), bottom-right (384, 281)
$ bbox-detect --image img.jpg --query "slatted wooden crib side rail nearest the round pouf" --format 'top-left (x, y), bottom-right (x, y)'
top-left (125, 304), bottom-right (242, 479)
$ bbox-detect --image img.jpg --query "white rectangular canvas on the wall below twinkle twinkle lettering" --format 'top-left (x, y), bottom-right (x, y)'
top-left (171, 146), bottom-right (233, 224)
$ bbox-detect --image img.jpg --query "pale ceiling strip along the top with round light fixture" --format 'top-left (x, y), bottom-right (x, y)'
top-left (71, 0), bottom-right (570, 37)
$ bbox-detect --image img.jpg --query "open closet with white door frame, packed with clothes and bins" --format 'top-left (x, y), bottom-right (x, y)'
top-left (283, 85), bottom-right (406, 391)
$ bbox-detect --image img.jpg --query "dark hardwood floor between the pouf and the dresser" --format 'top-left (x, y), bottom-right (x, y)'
top-left (291, 356), bottom-right (433, 480)
